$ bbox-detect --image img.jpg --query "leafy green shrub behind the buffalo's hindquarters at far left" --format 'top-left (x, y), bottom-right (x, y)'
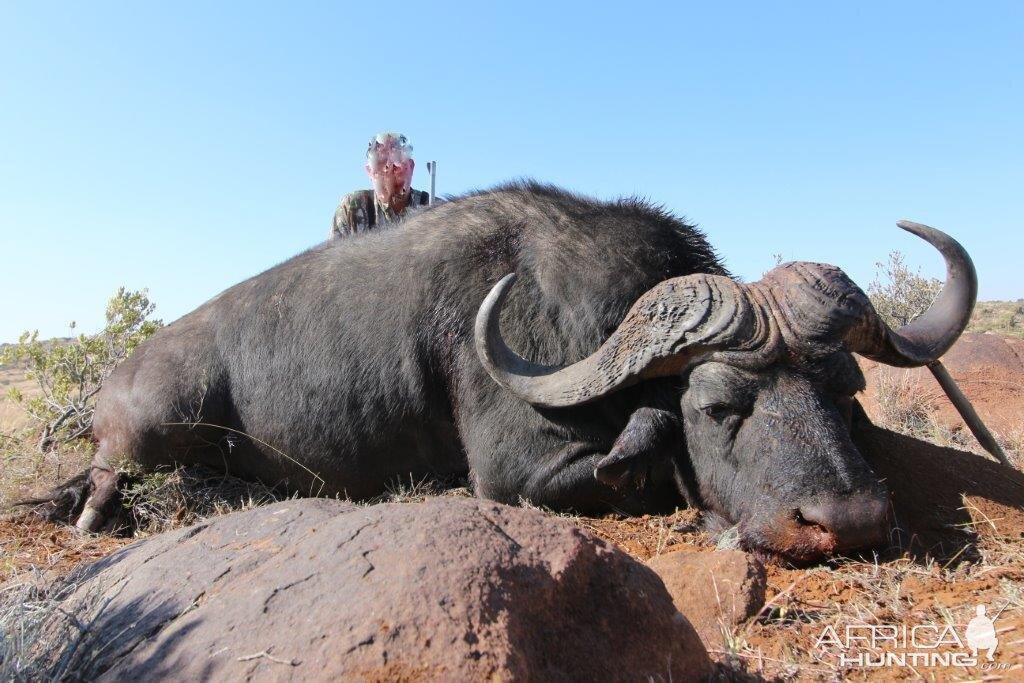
top-left (0, 287), bottom-right (163, 452)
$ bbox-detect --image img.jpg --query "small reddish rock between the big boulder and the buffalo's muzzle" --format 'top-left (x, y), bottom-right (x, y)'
top-left (647, 550), bottom-right (767, 648)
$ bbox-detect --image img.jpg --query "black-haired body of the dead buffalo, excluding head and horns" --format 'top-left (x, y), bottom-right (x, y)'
top-left (86, 182), bottom-right (727, 510)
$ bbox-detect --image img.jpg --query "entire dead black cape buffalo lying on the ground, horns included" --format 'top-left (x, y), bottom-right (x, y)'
top-left (51, 183), bottom-right (976, 560)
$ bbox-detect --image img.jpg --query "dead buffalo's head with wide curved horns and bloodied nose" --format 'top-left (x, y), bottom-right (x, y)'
top-left (476, 221), bottom-right (977, 561)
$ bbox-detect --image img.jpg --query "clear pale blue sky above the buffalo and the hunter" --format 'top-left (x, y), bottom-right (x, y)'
top-left (0, 2), bottom-right (1024, 341)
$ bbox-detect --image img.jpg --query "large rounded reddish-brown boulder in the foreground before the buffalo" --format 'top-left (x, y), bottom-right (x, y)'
top-left (25, 499), bottom-right (711, 681)
